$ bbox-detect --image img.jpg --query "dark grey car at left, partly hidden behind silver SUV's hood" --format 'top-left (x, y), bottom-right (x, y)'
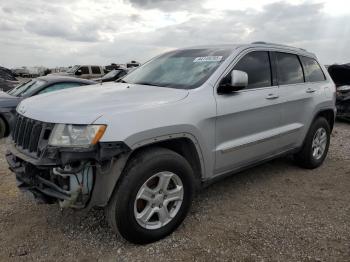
top-left (0, 76), bottom-right (96, 138)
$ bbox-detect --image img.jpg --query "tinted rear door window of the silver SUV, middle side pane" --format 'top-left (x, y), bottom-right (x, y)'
top-left (276, 52), bottom-right (304, 85)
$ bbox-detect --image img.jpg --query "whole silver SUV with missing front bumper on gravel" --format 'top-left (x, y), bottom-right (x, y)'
top-left (6, 42), bottom-right (336, 243)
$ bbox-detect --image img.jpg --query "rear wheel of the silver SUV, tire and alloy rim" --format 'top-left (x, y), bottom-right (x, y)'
top-left (294, 117), bottom-right (331, 169)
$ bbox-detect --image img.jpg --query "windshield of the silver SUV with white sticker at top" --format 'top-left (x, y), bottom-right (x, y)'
top-left (122, 49), bottom-right (230, 89)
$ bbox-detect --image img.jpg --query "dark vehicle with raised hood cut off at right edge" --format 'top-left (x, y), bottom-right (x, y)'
top-left (328, 64), bottom-right (350, 120)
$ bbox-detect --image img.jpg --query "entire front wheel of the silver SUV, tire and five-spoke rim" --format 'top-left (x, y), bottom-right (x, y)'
top-left (105, 147), bottom-right (194, 244)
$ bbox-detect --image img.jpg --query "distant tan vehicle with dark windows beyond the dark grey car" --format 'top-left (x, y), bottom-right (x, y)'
top-left (51, 65), bottom-right (105, 79)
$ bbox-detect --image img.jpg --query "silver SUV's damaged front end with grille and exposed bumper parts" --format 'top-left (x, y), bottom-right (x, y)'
top-left (6, 115), bottom-right (130, 209)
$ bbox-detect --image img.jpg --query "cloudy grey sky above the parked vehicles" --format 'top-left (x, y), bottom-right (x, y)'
top-left (0, 0), bottom-right (350, 68)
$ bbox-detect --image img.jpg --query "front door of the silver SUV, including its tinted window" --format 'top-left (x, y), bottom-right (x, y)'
top-left (215, 51), bottom-right (281, 175)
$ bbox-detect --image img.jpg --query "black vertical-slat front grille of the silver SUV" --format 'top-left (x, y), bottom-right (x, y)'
top-left (12, 114), bottom-right (53, 157)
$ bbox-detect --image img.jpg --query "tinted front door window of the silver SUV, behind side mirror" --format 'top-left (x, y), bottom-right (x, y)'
top-left (234, 51), bottom-right (271, 89)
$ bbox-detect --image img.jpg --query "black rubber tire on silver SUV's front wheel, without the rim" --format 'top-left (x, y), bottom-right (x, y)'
top-left (116, 150), bottom-right (194, 243)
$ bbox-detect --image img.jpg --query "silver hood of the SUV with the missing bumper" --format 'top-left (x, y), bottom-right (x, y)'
top-left (17, 82), bottom-right (188, 124)
